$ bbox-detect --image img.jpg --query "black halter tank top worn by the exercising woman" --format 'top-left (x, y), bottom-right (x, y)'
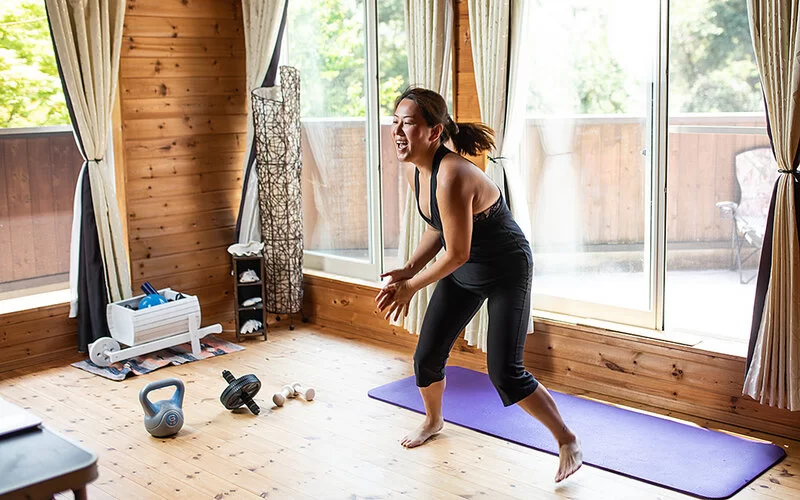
top-left (414, 146), bottom-right (533, 285)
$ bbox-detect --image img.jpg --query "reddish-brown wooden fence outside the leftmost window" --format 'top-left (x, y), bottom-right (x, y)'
top-left (0, 132), bottom-right (83, 283)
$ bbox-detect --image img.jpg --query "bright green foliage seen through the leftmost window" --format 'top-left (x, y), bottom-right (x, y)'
top-left (0, 0), bottom-right (69, 128)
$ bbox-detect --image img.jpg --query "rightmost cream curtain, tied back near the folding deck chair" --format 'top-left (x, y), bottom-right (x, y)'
top-left (743, 0), bottom-right (800, 411)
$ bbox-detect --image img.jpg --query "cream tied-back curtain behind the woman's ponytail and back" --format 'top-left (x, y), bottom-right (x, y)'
top-left (465, 0), bottom-right (533, 351)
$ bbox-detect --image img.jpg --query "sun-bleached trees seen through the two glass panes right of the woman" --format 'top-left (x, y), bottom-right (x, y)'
top-left (528, 0), bottom-right (763, 114)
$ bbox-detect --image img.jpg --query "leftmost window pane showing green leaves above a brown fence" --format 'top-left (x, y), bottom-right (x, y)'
top-left (0, 0), bottom-right (76, 302)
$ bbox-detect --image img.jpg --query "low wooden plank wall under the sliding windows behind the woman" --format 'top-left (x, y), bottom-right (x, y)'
top-left (304, 274), bottom-right (800, 439)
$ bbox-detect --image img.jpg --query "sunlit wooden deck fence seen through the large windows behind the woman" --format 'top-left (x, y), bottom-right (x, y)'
top-left (303, 113), bottom-right (769, 250)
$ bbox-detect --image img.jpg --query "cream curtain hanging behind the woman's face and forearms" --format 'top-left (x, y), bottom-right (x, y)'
top-left (396, 0), bottom-right (453, 334)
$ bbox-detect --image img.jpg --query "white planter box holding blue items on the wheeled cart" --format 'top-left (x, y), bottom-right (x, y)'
top-left (106, 288), bottom-right (200, 346)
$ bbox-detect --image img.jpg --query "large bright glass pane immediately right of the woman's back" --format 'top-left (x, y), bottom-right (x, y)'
top-left (520, 0), bottom-right (658, 312)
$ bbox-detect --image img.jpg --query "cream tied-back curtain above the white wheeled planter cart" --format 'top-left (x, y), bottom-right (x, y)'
top-left (45, 0), bottom-right (131, 317)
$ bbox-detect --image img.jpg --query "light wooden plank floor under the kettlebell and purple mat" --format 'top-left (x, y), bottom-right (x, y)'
top-left (0, 326), bottom-right (800, 500)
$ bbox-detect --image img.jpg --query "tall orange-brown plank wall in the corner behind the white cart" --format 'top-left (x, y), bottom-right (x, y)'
top-left (120, 0), bottom-right (247, 332)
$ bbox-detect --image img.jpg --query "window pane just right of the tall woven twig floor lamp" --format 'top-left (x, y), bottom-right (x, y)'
top-left (284, 0), bottom-right (369, 260)
